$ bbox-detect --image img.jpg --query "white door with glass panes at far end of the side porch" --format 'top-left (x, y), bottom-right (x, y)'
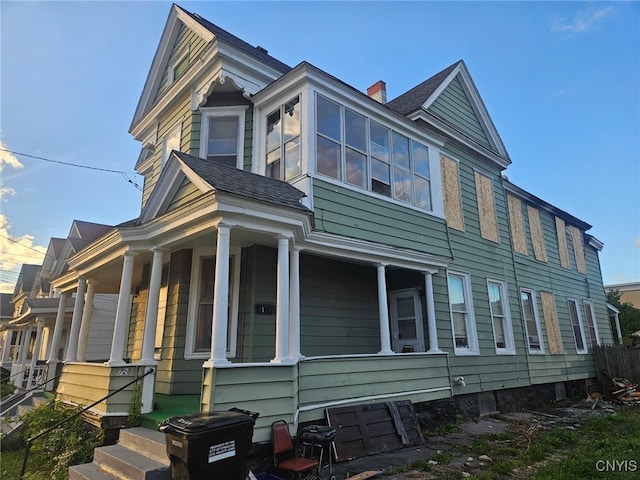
top-left (389, 288), bottom-right (424, 353)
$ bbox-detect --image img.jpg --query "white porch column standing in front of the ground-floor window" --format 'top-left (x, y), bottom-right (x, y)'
top-left (203, 223), bottom-right (231, 368)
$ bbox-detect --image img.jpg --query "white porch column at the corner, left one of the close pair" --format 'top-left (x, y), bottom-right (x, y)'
top-left (271, 236), bottom-right (291, 363)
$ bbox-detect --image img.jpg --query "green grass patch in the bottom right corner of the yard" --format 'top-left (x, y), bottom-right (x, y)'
top-left (386, 407), bottom-right (640, 480)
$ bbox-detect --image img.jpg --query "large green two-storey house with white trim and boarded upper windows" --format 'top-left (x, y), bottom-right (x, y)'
top-left (41, 5), bottom-right (612, 441)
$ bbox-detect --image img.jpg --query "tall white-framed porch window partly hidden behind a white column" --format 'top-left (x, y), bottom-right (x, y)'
top-left (185, 249), bottom-right (240, 359)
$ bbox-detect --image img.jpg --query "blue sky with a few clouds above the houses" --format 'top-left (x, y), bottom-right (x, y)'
top-left (0, 0), bottom-right (640, 291)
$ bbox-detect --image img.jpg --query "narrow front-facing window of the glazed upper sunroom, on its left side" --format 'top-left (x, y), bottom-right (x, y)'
top-left (266, 96), bottom-right (302, 181)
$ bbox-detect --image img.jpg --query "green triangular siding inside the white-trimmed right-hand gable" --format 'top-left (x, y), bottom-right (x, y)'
top-left (428, 77), bottom-right (491, 148)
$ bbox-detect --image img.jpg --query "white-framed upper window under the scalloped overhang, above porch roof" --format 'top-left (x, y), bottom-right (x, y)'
top-left (200, 107), bottom-right (246, 168)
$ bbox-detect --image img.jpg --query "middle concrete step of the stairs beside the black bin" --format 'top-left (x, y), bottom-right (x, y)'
top-left (93, 445), bottom-right (171, 480)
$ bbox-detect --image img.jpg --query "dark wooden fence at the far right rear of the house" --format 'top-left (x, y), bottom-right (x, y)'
top-left (593, 345), bottom-right (640, 393)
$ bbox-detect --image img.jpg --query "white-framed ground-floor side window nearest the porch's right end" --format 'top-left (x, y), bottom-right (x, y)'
top-left (447, 272), bottom-right (480, 355)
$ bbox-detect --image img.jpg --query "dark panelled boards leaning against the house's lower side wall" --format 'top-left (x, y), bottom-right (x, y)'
top-left (327, 400), bottom-right (424, 462)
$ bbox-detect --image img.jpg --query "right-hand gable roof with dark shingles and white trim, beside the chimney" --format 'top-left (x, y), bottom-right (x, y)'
top-left (387, 60), bottom-right (511, 168)
